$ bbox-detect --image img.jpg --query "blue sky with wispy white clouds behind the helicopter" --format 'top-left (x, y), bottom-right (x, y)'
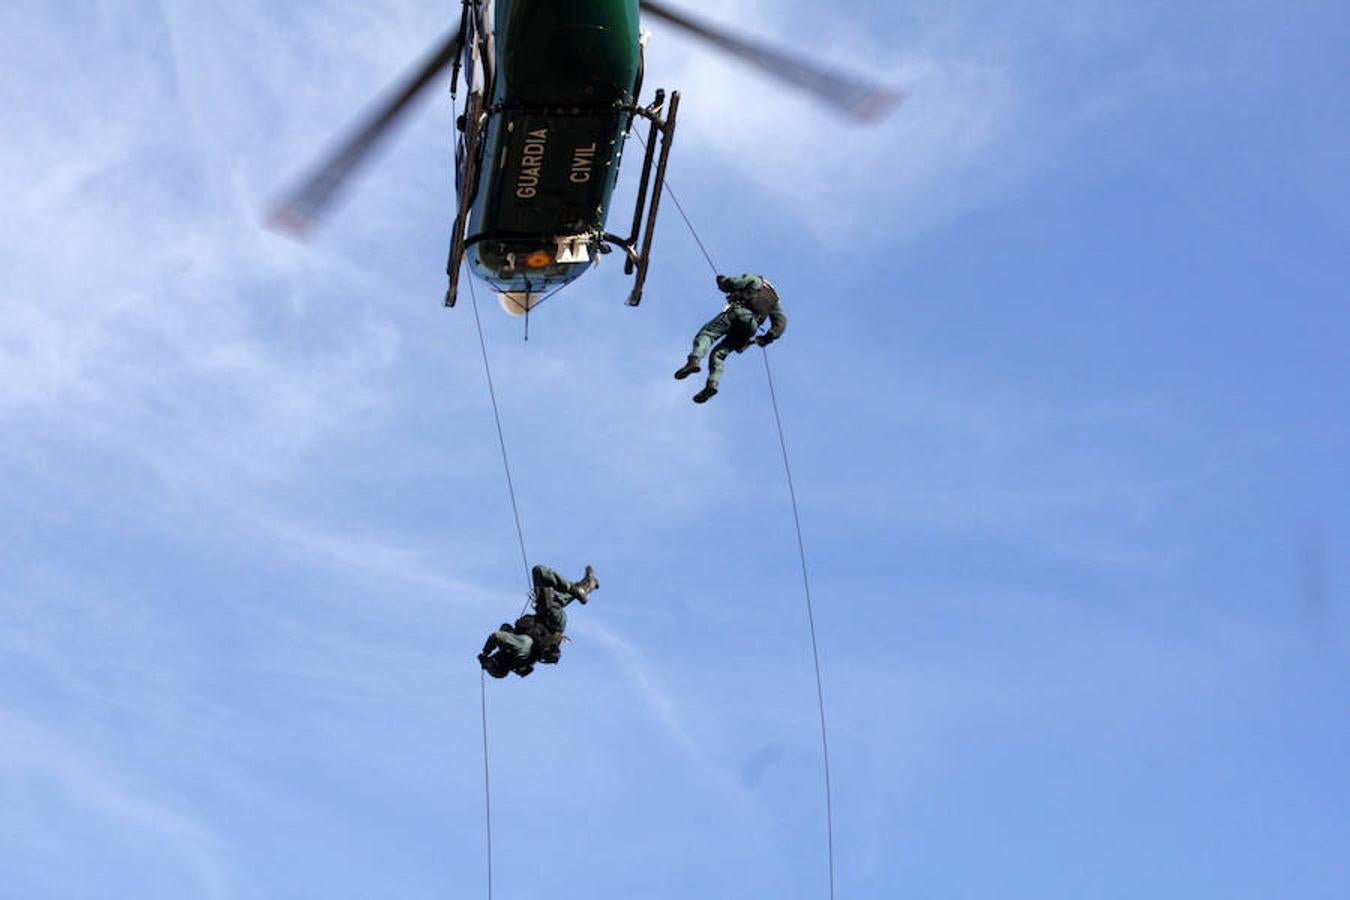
top-left (0, 0), bottom-right (1350, 900)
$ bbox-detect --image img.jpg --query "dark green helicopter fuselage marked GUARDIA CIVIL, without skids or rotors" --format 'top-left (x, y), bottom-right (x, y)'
top-left (458, 0), bottom-right (641, 293)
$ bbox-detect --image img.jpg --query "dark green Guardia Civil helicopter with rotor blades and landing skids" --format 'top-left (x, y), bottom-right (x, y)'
top-left (269, 0), bottom-right (903, 314)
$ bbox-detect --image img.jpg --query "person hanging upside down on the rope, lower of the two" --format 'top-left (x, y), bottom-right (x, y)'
top-left (478, 565), bottom-right (599, 679)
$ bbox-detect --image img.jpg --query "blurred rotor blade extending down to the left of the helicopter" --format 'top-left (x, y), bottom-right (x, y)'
top-left (267, 32), bottom-right (462, 237)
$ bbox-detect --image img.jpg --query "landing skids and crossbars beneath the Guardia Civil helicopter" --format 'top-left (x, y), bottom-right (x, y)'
top-left (446, 90), bottom-right (679, 306)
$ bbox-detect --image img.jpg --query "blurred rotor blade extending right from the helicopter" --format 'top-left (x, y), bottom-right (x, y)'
top-left (640, 0), bottom-right (905, 121)
